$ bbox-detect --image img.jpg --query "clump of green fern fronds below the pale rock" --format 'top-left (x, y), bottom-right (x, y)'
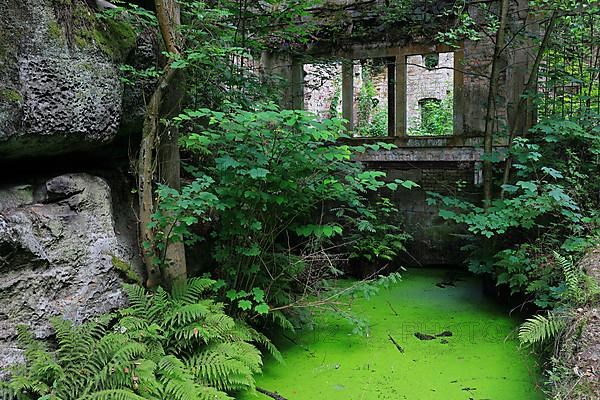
top-left (0, 278), bottom-right (279, 400)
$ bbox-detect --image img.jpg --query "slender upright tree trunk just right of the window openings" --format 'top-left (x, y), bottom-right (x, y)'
top-left (483, 0), bottom-right (508, 210)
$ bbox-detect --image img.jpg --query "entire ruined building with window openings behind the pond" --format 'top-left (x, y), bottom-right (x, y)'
top-left (261, 0), bottom-right (539, 264)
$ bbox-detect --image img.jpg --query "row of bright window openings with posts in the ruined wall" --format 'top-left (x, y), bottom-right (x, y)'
top-left (300, 46), bottom-right (464, 138)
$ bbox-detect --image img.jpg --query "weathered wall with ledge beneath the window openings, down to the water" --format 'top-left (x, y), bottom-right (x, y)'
top-left (359, 147), bottom-right (481, 266)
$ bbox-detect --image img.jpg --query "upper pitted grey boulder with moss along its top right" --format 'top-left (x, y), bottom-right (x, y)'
top-left (0, 0), bottom-right (135, 159)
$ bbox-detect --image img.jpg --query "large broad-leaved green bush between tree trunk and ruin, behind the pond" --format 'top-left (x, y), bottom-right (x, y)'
top-left (148, 104), bottom-right (414, 318)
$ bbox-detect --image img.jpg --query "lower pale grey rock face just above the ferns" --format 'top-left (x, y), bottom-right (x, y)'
top-left (0, 174), bottom-right (139, 375)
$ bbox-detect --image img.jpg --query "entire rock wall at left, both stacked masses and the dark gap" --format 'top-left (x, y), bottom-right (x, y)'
top-left (0, 0), bottom-right (146, 372)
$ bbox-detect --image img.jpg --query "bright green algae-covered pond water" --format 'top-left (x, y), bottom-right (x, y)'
top-left (239, 269), bottom-right (543, 400)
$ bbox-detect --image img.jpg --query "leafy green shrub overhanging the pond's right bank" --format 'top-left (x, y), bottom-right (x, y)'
top-left (428, 101), bottom-right (600, 308)
